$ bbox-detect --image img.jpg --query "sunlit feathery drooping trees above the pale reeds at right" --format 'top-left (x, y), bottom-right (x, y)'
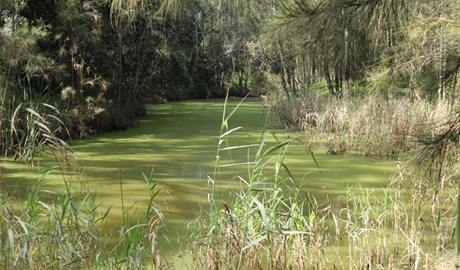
top-left (256, 0), bottom-right (458, 99)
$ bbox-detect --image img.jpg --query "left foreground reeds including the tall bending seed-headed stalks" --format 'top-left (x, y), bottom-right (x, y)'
top-left (0, 105), bottom-right (166, 269)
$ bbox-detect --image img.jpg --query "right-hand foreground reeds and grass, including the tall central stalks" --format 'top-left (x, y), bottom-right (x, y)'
top-left (187, 91), bottom-right (459, 269)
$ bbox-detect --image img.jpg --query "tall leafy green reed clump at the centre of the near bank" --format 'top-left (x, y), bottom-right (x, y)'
top-left (189, 130), bottom-right (327, 269)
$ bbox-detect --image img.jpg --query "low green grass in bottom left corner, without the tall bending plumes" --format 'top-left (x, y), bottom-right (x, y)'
top-left (0, 166), bottom-right (162, 269)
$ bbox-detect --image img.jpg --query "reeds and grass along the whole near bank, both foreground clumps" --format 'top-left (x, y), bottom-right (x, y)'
top-left (0, 93), bottom-right (459, 269)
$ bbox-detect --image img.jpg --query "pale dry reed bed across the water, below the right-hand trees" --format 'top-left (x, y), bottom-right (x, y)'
top-left (268, 91), bottom-right (451, 157)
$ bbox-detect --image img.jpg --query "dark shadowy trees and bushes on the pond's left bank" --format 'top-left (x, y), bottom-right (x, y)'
top-left (0, 0), bottom-right (253, 151)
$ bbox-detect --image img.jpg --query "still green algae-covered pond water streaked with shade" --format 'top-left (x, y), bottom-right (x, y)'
top-left (0, 98), bottom-right (396, 255)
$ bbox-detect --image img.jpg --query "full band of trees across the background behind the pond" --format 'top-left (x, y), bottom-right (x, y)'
top-left (0, 0), bottom-right (460, 146)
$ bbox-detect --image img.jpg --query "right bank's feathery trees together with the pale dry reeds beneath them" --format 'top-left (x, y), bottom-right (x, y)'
top-left (266, 0), bottom-right (460, 159)
